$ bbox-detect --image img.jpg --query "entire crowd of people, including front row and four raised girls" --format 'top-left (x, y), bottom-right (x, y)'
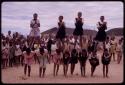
top-left (1, 12), bottom-right (123, 77)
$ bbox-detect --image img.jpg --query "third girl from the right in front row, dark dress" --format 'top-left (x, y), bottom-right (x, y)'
top-left (79, 49), bottom-right (87, 77)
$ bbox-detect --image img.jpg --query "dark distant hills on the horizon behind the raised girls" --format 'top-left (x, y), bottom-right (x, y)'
top-left (41, 27), bottom-right (123, 36)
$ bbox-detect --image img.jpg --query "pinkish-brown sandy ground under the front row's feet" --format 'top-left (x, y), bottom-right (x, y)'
top-left (2, 50), bottom-right (123, 83)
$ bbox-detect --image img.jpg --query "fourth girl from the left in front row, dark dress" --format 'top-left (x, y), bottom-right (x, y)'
top-left (63, 51), bottom-right (70, 77)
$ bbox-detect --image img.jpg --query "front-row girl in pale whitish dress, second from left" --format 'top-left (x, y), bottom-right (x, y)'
top-left (36, 48), bottom-right (48, 77)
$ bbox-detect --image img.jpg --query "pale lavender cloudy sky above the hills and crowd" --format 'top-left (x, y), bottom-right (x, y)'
top-left (1, 1), bottom-right (123, 35)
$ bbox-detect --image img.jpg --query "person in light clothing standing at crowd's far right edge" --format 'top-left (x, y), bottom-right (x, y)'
top-left (116, 40), bottom-right (122, 64)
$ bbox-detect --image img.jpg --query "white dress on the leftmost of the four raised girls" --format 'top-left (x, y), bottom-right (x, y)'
top-left (29, 19), bottom-right (40, 37)
